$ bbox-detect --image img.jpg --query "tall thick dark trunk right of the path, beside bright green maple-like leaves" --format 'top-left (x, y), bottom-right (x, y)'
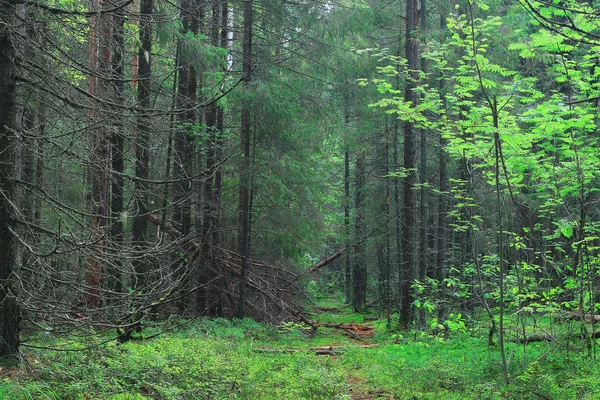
top-left (400, 0), bottom-right (419, 325)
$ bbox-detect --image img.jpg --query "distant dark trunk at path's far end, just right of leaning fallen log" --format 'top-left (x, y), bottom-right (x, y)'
top-left (352, 150), bottom-right (367, 311)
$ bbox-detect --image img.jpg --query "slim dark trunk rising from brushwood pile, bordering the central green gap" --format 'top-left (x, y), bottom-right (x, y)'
top-left (237, 0), bottom-right (253, 318)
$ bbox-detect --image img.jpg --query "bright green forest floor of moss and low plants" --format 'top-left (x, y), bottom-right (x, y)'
top-left (0, 303), bottom-right (600, 400)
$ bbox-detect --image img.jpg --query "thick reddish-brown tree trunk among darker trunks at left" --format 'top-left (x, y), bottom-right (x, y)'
top-left (86, 0), bottom-right (113, 308)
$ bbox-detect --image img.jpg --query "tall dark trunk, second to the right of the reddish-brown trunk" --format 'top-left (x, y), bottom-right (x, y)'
top-left (131, 0), bottom-right (154, 289)
